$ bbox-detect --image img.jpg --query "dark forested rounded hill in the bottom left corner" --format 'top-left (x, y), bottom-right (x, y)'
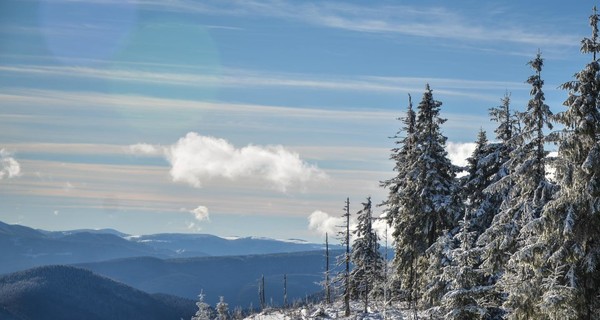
top-left (0, 266), bottom-right (196, 320)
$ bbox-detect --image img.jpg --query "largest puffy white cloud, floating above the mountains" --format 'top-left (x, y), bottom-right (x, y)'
top-left (166, 132), bottom-right (326, 192)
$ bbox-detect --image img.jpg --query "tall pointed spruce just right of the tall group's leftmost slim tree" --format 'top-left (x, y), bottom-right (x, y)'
top-left (414, 85), bottom-right (462, 306)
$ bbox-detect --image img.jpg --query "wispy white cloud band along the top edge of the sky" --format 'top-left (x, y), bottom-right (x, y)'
top-left (125, 0), bottom-right (579, 47)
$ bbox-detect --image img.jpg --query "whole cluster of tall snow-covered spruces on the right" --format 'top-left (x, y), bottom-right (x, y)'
top-left (372, 8), bottom-right (600, 319)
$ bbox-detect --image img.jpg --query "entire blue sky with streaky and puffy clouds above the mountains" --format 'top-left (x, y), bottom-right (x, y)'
top-left (0, 0), bottom-right (593, 242)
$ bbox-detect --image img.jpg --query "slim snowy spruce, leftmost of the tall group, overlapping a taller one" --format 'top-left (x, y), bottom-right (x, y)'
top-left (380, 95), bottom-right (418, 302)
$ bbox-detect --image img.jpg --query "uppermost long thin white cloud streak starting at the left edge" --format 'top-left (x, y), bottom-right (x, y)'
top-left (0, 65), bottom-right (527, 101)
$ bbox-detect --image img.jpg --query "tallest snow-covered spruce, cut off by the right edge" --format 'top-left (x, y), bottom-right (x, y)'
top-left (540, 7), bottom-right (600, 320)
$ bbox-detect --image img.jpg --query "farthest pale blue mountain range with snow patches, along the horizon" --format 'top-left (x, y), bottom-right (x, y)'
top-left (0, 222), bottom-right (335, 276)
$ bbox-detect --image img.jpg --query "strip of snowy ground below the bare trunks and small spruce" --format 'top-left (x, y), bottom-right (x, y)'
top-left (245, 302), bottom-right (424, 320)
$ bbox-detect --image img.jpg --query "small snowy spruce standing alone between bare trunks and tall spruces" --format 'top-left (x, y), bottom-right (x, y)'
top-left (350, 197), bottom-right (384, 312)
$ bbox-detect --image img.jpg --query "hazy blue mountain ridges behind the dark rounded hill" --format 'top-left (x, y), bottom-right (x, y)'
top-left (0, 222), bottom-right (342, 308)
